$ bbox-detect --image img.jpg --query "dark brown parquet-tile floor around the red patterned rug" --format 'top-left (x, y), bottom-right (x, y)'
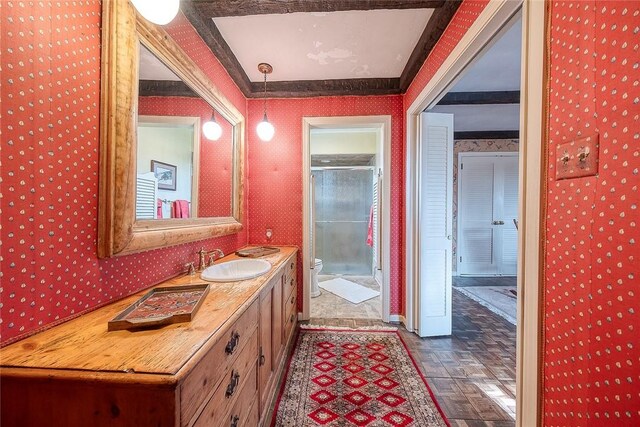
top-left (302, 290), bottom-right (516, 427)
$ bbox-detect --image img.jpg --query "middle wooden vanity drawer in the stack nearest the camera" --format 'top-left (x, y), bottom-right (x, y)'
top-left (194, 329), bottom-right (258, 427)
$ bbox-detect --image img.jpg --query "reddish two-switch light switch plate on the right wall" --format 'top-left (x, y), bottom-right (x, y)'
top-left (556, 134), bottom-right (599, 180)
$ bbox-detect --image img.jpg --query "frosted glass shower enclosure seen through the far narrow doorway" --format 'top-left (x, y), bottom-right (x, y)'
top-left (311, 167), bottom-right (373, 276)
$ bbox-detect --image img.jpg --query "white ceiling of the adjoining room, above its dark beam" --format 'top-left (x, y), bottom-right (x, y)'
top-left (450, 18), bottom-right (522, 92)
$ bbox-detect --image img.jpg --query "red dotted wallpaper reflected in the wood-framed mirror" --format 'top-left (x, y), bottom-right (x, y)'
top-left (138, 96), bottom-right (233, 217)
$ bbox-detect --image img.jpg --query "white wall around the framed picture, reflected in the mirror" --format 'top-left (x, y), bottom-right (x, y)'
top-left (137, 124), bottom-right (193, 206)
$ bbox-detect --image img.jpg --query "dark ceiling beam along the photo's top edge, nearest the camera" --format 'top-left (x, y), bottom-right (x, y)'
top-left (191, 0), bottom-right (448, 17)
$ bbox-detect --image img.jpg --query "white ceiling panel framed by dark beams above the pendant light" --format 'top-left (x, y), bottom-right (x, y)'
top-left (213, 9), bottom-right (433, 82)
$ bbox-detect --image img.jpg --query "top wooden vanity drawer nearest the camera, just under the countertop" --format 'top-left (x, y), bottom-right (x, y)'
top-left (180, 301), bottom-right (258, 425)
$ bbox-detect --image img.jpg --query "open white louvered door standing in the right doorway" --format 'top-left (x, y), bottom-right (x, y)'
top-left (418, 113), bottom-right (453, 337)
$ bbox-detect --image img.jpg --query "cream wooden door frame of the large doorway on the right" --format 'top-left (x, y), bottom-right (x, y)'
top-left (404, 0), bottom-right (547, 427)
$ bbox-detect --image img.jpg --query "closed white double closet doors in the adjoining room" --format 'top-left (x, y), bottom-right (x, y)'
top-left (457, 153), bottom-right (518, 276)
